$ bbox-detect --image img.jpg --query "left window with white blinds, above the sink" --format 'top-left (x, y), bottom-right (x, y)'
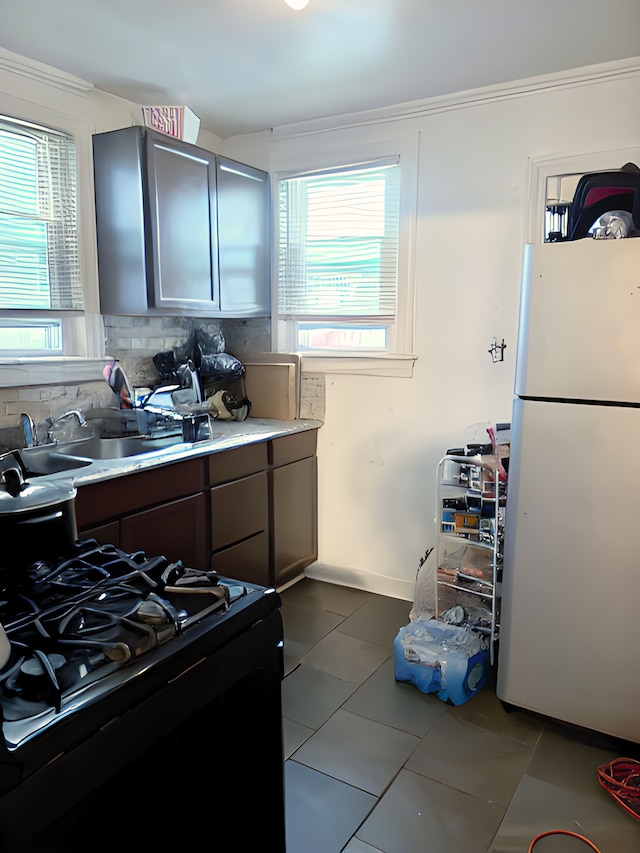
top-left (0, 116), bottom-right (83, 356)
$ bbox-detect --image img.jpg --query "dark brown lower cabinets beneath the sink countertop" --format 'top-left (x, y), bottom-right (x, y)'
top-left (76, 430), bottom-right (318, 587)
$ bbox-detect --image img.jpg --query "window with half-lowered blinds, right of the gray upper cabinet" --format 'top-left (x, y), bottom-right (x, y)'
top-left (277, 158), bottom-right (400, 355)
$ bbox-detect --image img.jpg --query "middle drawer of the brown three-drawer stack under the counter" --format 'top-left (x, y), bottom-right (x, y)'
top-left (211, 471), bottom-right (269, 551)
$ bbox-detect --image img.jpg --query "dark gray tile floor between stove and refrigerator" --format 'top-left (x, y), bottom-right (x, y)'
top-left (281, 578), bottom-right (640, 853)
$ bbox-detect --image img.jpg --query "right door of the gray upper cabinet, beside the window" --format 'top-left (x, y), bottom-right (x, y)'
top-left (217, 157), bottom-right (271, 317)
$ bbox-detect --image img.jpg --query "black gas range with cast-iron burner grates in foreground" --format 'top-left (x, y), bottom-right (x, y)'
top-left (0, 540), bottom-right (285, 853)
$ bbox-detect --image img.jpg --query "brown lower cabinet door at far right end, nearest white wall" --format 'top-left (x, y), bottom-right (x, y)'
top-left (271, 456), bottom-right (318, 587)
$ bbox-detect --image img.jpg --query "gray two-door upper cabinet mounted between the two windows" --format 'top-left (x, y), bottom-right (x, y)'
top-left (93, 126), bottom-right (270, 317)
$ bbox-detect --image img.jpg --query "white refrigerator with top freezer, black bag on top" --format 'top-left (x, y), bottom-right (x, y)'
top-left (497, 238), bottom-right (640, 743)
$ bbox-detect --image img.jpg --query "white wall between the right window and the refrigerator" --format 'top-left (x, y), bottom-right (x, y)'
top-left (225, 66), bottom-right (640, 600)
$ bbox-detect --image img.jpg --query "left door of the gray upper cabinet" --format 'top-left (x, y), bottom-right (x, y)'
top-left (146, 133), bottom-right (220, 311)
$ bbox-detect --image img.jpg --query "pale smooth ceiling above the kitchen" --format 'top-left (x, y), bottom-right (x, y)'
top-left (0, 0), bottom-right (640, 138)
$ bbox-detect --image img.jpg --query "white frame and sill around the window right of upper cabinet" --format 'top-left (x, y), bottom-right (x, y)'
top-left (270, 128), bottom-right (420, 377)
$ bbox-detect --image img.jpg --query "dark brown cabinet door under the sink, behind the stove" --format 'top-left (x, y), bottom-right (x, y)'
top-left (120, 494), bottom-right (209, 571)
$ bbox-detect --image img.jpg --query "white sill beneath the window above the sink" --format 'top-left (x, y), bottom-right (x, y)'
top-left (0, 357), bottom-right (110, 388)
